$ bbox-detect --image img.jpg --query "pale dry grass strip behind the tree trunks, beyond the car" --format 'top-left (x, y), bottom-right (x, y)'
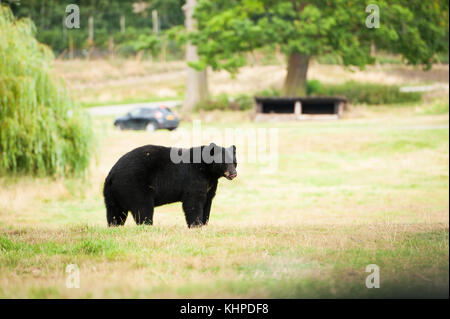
top-left (54, 59), bottom-right (448, 105)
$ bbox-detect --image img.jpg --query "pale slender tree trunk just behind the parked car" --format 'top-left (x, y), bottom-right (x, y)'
top-left (183, 0), bottom-right (209, 112)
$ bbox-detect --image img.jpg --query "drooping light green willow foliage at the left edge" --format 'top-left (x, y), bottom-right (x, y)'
top-left (0, 6), bottom-right (93, 175)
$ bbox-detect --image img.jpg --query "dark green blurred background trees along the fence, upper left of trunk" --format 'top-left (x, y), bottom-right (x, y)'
top-left (2, 0), bottom-right (184, 59)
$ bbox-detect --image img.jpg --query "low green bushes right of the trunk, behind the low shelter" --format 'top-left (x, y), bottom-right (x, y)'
top-left (307, 80), bottom-right (422, 105)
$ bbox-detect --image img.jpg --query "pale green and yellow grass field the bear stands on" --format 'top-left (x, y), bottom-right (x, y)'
top-left (0, 104), bottom-right (449, 298)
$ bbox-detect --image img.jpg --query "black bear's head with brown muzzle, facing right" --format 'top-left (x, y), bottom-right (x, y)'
top-left (202, 143), bottom-right (237, 180)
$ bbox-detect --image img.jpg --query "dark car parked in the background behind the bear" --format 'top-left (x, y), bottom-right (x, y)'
top-left (114, 106), bottom-right (180, 132)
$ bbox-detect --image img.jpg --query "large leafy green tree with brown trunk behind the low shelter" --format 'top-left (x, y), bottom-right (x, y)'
top-left (190, 0), bottom-right (448, 96)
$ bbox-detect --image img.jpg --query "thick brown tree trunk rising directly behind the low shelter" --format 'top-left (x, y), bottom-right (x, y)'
top-left (283, 53), bottom-right (310, 96)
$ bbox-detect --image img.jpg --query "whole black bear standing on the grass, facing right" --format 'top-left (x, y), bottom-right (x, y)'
top-left (103, 143), bottom-right (237, 227)
